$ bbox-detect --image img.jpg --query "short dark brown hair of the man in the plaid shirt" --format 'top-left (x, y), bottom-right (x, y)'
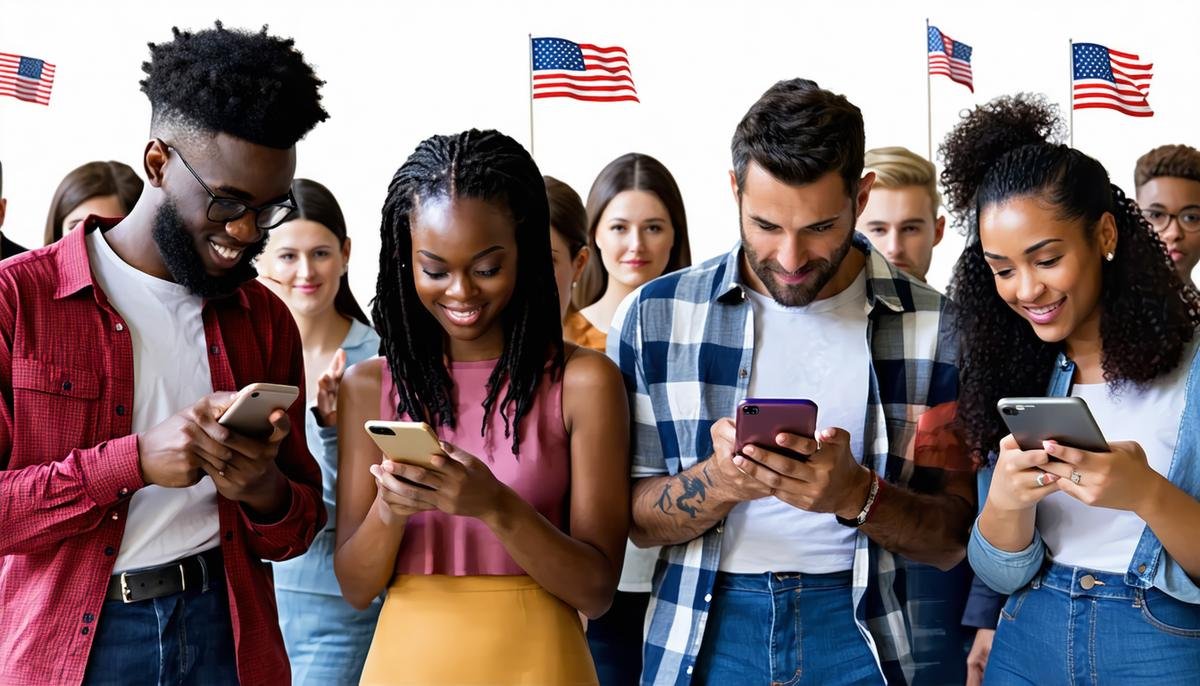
top-left (729, 78), bottom-right (866, 194)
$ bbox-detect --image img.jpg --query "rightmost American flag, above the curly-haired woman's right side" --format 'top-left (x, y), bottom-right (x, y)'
top-left (1070, 43), bottom-right (1154, 116)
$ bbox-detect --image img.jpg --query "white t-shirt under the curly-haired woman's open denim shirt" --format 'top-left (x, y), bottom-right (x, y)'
top-left (1037, 345), bottom-right (1195, 573)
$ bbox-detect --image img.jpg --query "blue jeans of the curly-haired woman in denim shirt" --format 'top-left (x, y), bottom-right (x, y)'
top-left (984, 564), bottom-right (1200, 686)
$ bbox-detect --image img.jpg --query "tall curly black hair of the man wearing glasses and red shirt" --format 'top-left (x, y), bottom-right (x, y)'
top-left (140, 22), bottom-right (329, 150)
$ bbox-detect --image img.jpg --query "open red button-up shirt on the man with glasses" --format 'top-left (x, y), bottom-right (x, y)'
top-left (0, 218), bottom-right (325, 685)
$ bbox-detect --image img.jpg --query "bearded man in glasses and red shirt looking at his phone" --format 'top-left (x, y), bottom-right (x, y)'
top-left (0, 23), bottom-right (326, 684)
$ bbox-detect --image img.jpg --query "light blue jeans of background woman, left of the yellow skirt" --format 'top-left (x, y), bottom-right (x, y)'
top-left (275, 589), bottom-right (383, 686)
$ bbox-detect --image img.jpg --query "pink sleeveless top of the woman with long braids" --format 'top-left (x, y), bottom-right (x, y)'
top-left (379, 360), bottom-right (570, 577)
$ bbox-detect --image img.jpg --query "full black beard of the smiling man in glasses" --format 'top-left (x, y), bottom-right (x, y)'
top-left (154, 200), bottom-right (266, 299)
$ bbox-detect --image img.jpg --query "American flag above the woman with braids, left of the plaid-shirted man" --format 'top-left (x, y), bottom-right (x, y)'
top-left (529, 38), bottom-right (640, 102)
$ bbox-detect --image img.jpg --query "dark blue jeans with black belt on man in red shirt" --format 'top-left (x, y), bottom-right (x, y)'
top-left (83, 570), bottom-right (238, 686)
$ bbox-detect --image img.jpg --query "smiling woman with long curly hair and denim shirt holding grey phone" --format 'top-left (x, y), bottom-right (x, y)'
top-left (942, 96), bottom-right (1200, 685)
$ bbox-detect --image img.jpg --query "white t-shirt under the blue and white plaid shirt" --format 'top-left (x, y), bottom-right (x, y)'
top-left (719, 273), bottom-right (871, 573)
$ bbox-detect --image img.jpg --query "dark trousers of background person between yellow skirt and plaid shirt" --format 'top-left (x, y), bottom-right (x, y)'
top-left (588, 591), bottom-right (650, 686)
